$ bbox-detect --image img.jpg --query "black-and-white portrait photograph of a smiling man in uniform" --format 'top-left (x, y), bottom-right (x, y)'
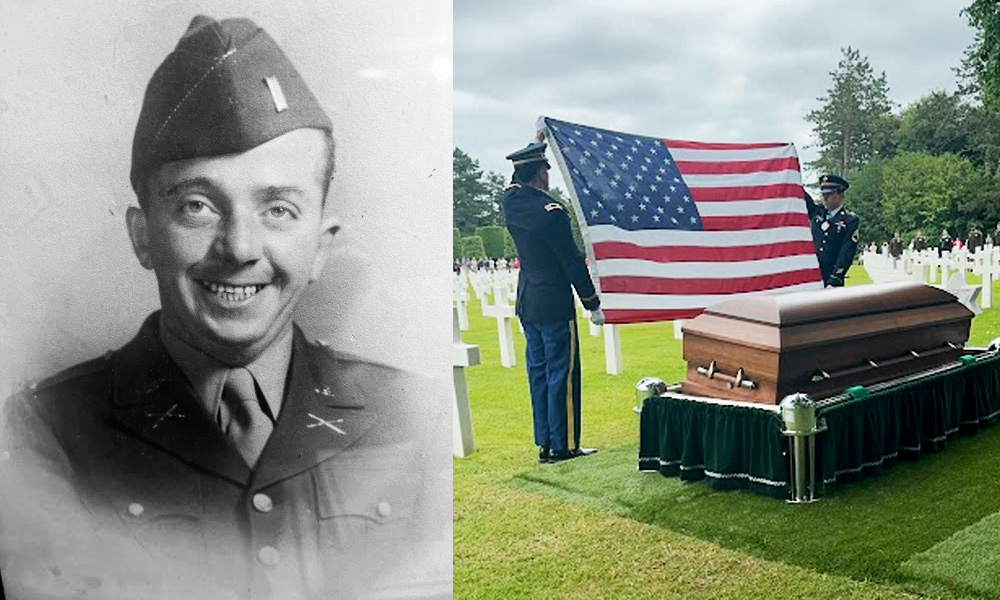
top-left (0, 0), bottom-right (452, 599)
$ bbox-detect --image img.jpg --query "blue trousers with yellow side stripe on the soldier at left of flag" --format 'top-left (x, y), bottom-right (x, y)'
top-left (521, 319), bottom-right (580, 452)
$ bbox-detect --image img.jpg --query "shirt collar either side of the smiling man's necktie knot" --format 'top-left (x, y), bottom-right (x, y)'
top-left (160, 319), bottom-right (292, 419)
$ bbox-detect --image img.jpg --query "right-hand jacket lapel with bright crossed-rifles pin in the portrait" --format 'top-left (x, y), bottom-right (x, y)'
top-left (252, 327), bottom-right (376, 488)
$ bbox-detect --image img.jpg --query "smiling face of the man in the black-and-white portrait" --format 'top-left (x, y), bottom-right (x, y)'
top-left (128, 129), bottom-right (337, 362)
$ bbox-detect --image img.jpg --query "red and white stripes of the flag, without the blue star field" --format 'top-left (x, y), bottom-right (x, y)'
top-left (584, 140), bottom-right (822, 323)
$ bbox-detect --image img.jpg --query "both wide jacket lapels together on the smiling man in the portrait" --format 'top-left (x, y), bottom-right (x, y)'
top-left (112, 312), bottom-right (377, 488)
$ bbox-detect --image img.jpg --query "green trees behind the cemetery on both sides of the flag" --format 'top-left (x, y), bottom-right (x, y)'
top-left (453, 0), bottom-right (1000, 251)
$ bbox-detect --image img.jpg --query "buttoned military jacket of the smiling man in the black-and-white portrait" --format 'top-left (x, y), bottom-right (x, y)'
top-left (0, 314), bottom-right (451, 599)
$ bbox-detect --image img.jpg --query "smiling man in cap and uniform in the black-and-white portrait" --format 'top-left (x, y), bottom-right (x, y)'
top-left (0, 16), bottom-right (451, 599)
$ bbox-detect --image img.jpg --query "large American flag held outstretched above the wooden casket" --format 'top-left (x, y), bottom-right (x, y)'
top-left (543, 117), bottom-right (822, 323)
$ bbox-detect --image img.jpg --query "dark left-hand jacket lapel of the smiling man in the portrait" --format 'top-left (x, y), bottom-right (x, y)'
top-left (111, 312), bottom-right (250, 485)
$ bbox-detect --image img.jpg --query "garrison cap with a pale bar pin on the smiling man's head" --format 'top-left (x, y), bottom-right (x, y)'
top-left (130, 15), bottom-right (333, 197)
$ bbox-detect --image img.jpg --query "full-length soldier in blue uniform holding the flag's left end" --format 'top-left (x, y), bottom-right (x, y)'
top-left (503, 142), bottom-right (604, 463)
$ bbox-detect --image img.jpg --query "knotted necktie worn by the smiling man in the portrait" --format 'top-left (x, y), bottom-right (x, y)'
top-left (222, 367), bottom-right (274, 468)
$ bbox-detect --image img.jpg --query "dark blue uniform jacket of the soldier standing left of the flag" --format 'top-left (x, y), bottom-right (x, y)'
top-left (503, 184), bottom-right (601, 322)
